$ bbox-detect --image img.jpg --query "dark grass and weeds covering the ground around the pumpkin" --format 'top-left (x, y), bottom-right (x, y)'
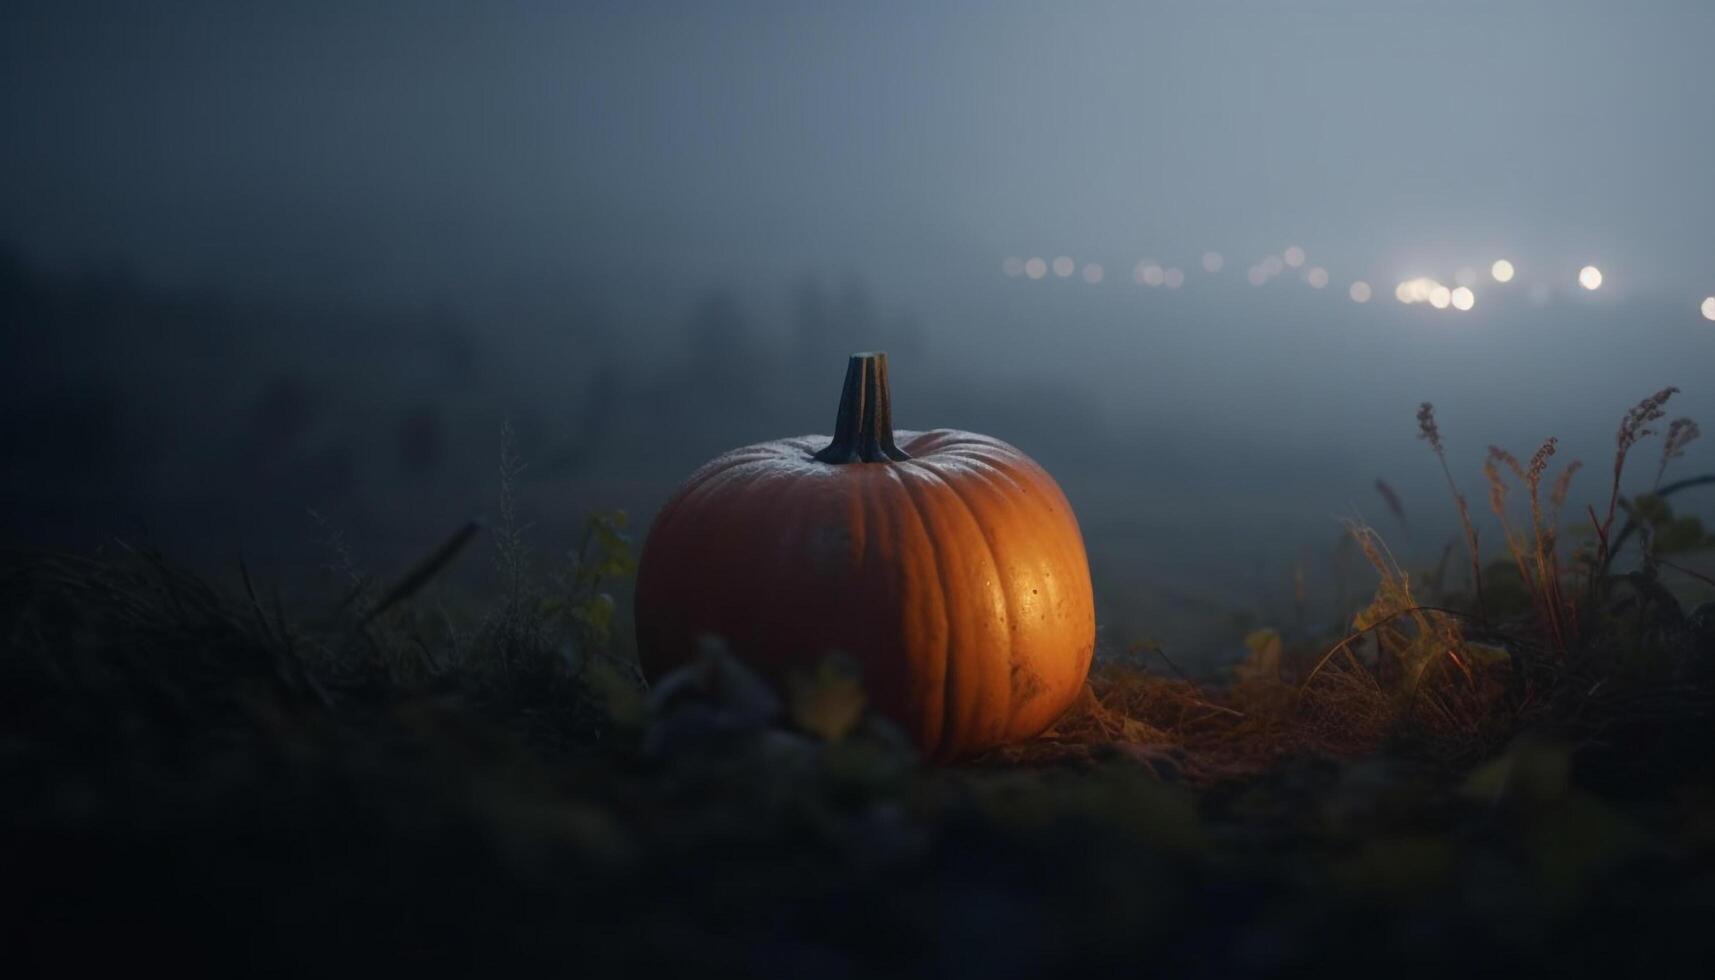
top-left (0, 391), bottom-right (1715, 977)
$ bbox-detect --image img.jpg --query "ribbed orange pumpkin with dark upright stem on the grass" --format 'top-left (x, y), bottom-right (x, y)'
top-left (636, 354), bottom-right (1096, 760)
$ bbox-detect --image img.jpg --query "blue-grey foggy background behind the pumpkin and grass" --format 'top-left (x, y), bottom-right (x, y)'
top-left (0, 0), bottom-right (1715, 649)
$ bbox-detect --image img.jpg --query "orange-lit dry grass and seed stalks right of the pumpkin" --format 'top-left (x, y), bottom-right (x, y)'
top-left (1000, 388), bottom-right (1712, 779)
